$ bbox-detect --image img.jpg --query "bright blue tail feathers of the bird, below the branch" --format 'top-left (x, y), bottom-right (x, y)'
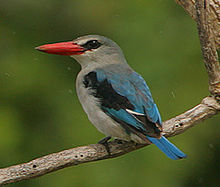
top-left (147, 136), bottom-right (186, 160)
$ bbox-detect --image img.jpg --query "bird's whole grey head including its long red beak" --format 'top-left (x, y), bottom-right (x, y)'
top-left (36, 35), bottom-right (127, 68)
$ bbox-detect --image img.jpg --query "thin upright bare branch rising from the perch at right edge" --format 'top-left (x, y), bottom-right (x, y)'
top-left (196, 0), bottom-right (220, 98)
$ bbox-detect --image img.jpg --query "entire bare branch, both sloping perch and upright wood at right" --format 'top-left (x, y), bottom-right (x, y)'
top-left (0, 0), bottom-right (220, 185)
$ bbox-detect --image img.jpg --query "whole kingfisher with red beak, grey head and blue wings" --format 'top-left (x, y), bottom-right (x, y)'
top-left (36, 35), bottom-right (186, 160)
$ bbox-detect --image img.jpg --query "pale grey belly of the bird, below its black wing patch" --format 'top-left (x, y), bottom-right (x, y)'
top-left (77, 85), bottom-right (131, 141)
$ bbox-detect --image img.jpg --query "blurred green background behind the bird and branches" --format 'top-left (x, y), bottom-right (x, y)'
top-left (0, 0), bottom-right (220, 187)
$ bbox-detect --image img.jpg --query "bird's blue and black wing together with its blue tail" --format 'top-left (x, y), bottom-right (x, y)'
top-left (84, 67), bottom-right (186, 160)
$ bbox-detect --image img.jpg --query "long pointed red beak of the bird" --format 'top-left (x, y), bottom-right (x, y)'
top-left (35, 42), bottom-right (86, 56)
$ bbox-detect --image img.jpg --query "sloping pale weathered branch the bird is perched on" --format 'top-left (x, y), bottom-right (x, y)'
top-left (0, 97), bottom-right (220, 185)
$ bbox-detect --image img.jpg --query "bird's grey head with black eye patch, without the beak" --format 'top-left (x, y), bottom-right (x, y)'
top-left (71, 35), bottom-right (127, 67)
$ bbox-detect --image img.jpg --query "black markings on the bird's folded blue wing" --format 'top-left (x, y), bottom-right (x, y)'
top-left (83, 71), bottom-right (162, 140)
